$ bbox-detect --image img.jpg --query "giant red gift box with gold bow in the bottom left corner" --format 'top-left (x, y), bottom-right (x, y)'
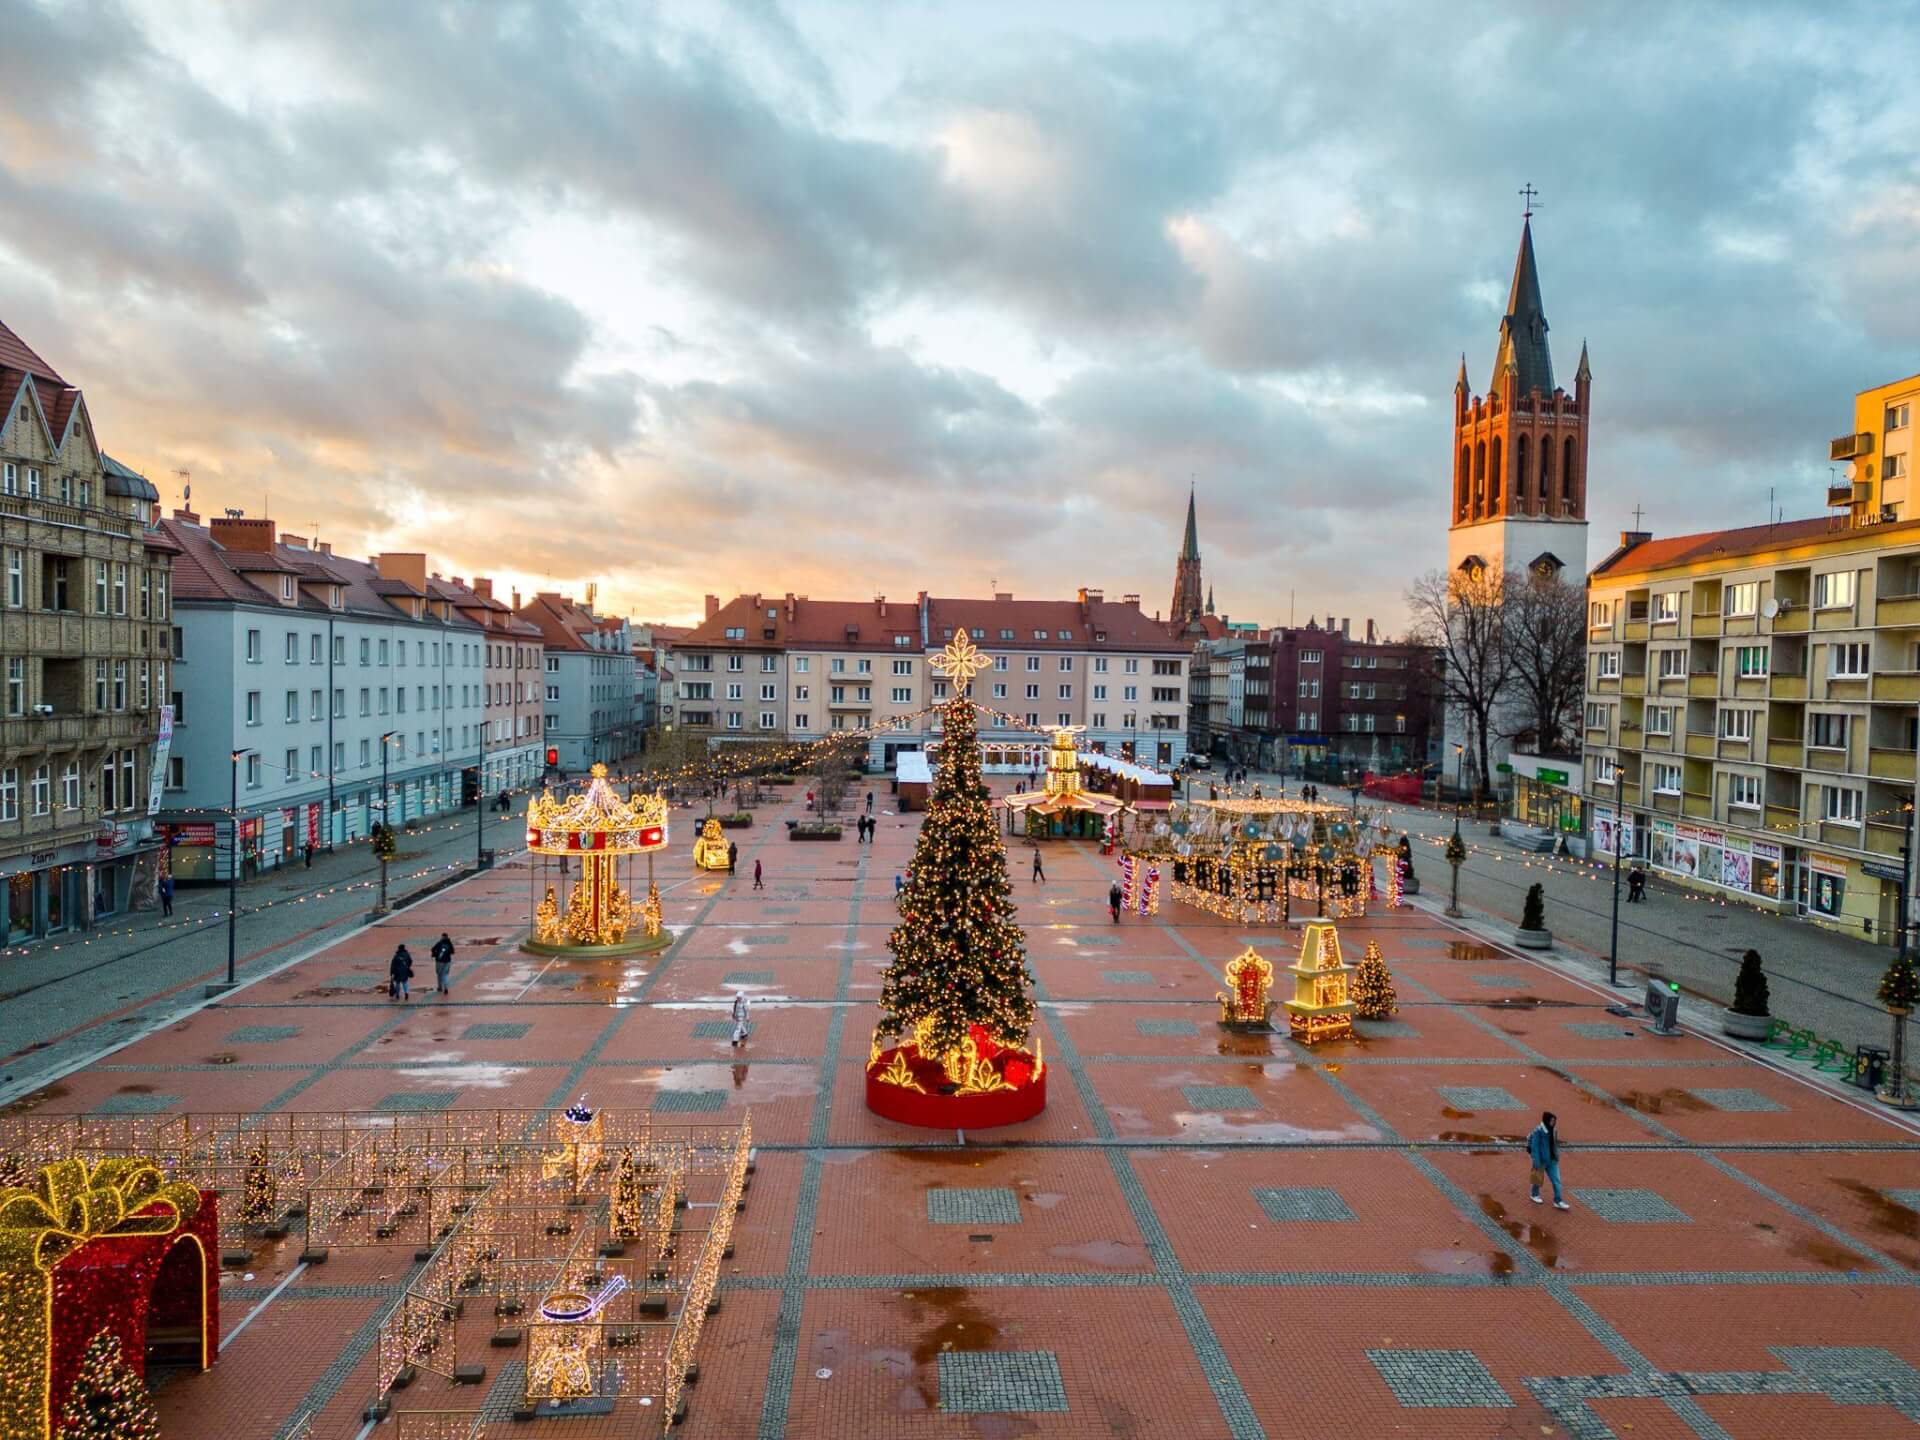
top-left (0, 1158), bottom-right (219, 1440)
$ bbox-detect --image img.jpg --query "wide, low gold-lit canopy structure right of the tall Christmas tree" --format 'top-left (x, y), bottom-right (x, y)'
top-left (1121, 795), bottom-right (1400, 924)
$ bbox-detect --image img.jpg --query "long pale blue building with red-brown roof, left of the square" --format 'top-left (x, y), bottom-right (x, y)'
top-left (161, 511), bottom-right (488, 879)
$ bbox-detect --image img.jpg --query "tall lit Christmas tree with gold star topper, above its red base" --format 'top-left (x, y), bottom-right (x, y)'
top-left (876, 645), bottom-right (1033, 1062)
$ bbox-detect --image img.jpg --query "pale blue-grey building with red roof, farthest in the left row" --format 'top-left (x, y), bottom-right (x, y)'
top-left (518, 591), bottom-right (639, 770)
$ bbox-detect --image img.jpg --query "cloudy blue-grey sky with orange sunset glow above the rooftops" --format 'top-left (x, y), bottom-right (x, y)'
top-left (0, 0), bottom-right (1920, 628)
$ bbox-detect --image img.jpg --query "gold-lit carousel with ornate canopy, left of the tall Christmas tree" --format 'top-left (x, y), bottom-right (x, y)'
top-left (520, 764), bottom-right (674, 958)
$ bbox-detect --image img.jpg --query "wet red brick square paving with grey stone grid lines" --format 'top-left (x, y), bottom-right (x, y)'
top-left (7, 787), bottom-right (1920, 1440)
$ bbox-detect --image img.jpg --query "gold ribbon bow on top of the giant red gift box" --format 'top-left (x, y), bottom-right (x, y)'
top-left (0, 1156), bottom-right (200, 1273)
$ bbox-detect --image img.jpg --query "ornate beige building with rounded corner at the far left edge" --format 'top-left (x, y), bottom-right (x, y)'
top-left (0, 324), bottom-right (173, 943)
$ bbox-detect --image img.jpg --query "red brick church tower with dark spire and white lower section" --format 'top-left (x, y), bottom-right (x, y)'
top-left (1448, 211), bottom-right (1594, 584)
